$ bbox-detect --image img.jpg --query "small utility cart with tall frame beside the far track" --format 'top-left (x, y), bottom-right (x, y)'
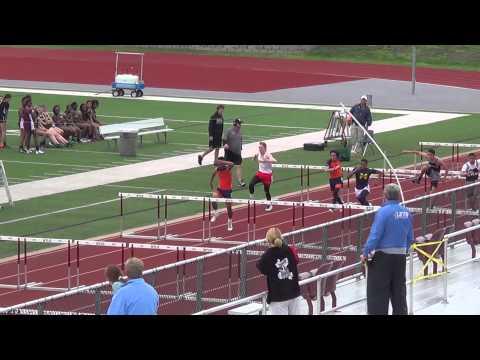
top-left (112, 51), bottom-right (145, 97)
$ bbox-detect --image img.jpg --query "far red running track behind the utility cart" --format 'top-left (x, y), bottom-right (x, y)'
top-left (0, 47), bottom-right (480, 92)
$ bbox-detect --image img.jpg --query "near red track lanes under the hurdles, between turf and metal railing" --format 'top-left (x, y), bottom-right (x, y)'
top-left (0, 155), bottom-right (472, 307)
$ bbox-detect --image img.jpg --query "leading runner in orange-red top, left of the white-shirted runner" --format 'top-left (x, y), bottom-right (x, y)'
top-left (210, 157), bottom-right (233, 231)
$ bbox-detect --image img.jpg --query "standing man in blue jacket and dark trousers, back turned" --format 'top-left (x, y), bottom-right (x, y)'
top-left (360, 184), bottom-right (413, 315)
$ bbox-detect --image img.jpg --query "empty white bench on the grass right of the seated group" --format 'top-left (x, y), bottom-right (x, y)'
top-left (100, 118), bottom-right (174, 145)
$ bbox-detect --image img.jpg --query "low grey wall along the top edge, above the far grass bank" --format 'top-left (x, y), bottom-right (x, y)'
top-left (135, 45), bottom-right (318, 52)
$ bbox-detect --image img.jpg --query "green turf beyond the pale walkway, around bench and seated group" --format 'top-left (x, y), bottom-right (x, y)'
top-left (0, 93), bottom-right (391, 184)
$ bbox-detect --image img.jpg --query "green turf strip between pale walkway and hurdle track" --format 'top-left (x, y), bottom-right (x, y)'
top-left (0, 104), bottom-right (480, 256)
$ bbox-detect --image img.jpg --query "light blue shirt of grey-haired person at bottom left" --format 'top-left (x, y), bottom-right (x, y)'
top-left (107, 279), bottom-right (158, 315)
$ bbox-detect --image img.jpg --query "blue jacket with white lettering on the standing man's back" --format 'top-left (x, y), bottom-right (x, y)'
top-left (363, 200), bottom-right (413, 256)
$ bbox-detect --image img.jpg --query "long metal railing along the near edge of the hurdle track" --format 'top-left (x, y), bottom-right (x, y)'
top-left (0, 183), bottom-right (480, 314)
